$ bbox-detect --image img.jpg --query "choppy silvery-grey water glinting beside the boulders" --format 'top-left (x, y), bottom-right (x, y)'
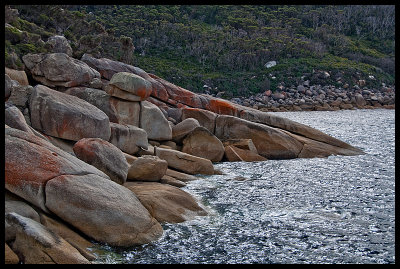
top-left (92, 110), bottom-right (395, 263)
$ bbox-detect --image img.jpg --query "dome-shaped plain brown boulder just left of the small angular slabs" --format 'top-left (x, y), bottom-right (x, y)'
top-left (182, 126), bottom-right (224, 162)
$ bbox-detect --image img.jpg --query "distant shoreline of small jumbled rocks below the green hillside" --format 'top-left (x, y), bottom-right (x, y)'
top-left (230, 80), bottom-right (395, 112)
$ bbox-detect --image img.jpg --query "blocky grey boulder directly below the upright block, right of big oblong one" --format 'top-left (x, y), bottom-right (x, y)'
top-left (110, 122), bottom-right (148, 154)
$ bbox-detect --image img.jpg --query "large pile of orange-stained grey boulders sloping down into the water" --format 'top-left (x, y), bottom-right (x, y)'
top-left (5, 53), bottom-right (363, 263)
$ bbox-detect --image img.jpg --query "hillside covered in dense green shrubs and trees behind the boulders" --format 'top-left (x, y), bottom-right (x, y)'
top-left (6, 5), bottom-right (395, 97)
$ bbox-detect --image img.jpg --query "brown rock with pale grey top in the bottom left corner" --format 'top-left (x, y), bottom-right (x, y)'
top-left (5, 213), bottom-right (90, 264)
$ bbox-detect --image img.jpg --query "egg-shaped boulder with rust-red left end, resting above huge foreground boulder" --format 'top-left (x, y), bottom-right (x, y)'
top-left (73, 138), bottom-right (129, 184)
